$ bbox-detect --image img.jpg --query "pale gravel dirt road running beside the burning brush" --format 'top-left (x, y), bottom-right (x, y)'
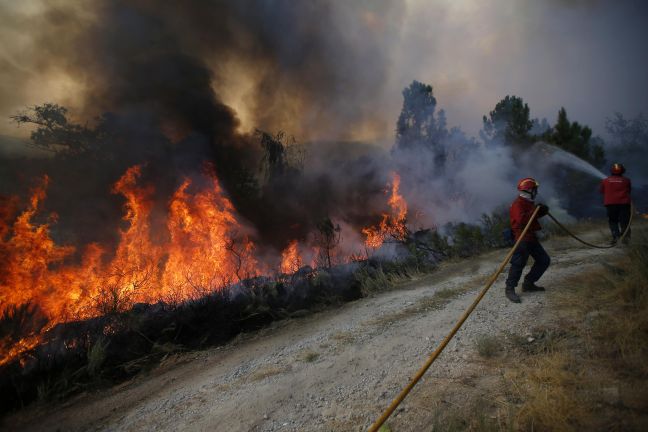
top-left (2, 228), bottom-right (620, 432)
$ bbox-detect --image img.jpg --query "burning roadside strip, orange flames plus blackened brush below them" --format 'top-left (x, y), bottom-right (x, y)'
top-left (0, 166), bottom-right (520, 411)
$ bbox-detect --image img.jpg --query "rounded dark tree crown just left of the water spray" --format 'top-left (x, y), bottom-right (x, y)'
top-left (482, 96), bottom-right (533, 146)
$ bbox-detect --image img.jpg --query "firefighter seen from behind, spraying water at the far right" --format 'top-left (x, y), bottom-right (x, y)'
top-left (599, 163), bottom-right (632, 244)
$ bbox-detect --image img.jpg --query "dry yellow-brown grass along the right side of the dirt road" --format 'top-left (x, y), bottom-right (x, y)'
top-left (390, 225), bottom-right (648, 432)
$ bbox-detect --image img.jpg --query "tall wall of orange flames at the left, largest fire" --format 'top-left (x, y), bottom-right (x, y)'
top-left (0, 165), bottom-right (258, 365)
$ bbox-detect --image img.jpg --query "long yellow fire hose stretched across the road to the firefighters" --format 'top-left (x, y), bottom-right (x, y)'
top-left (369, 206), bottom-right (634, 432)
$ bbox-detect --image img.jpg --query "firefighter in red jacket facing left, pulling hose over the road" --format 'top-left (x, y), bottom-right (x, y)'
top-left (506, 177), bottom-right (551, 303)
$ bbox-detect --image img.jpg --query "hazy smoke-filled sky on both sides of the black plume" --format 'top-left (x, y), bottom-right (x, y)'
top-left (0, 0), bottom-right (648, 142)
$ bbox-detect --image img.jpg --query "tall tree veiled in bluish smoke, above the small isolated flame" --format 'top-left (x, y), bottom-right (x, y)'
top-left (396, 81), bottom-right (448, 169)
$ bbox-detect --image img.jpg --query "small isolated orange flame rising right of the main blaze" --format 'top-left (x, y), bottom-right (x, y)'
top-left (362, 172), bottom-right (407, 249)
